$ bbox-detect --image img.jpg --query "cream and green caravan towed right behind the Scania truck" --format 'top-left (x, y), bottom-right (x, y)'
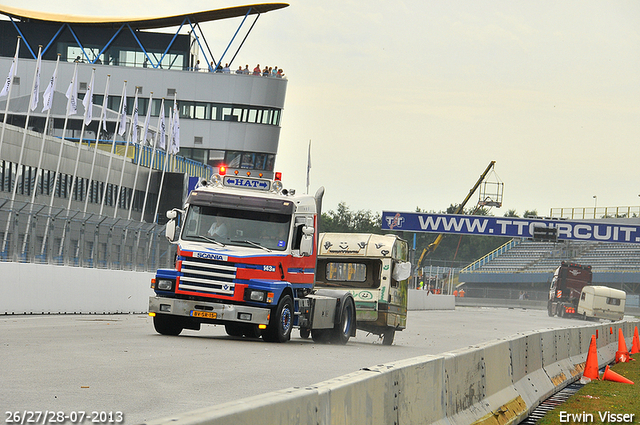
top-left (316, 233), bottom-right (411, 345)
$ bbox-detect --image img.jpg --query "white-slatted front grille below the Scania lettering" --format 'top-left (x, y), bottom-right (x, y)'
top-left (178, 258), bottom-right (237, 296)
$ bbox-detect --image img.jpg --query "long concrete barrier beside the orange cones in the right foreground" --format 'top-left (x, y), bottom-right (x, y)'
top-left (141, 320), bottom-right (640, 425)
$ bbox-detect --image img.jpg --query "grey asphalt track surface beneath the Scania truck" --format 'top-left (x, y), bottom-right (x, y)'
top-left (0, 307), bottom-right (596, 424)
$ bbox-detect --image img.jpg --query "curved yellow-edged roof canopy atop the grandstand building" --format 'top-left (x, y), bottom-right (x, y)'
top-left (0, 3), bottom-right (289, 29)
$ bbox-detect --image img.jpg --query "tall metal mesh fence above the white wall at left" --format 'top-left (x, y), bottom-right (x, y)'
top-left (0, 199), bottom-right (175, 271)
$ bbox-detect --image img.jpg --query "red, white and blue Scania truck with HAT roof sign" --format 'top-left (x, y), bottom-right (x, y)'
top-left (149, 168), bottom-right (356, 344)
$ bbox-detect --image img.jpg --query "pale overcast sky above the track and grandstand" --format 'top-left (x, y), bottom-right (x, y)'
top-left (3, 0), bottom-right (640, 215)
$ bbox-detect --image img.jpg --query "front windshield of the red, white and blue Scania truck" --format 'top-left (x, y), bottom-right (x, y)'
top-left (182, 205), bottom-right (291, 251)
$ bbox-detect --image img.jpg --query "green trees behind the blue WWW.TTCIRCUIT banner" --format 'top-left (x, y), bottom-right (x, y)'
top-left (319, 202), bottom-right (538, 267)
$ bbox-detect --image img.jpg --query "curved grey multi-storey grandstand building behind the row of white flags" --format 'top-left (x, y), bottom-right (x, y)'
top-left (0, 3), bottom-right (288, 222)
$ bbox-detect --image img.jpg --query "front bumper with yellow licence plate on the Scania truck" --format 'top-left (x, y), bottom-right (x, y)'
top-left (149, 297), bottom-right (271, 325)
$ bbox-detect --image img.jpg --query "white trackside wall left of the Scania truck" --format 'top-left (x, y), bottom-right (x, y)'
top-left (0, 263), bottom-right (154, 314)
